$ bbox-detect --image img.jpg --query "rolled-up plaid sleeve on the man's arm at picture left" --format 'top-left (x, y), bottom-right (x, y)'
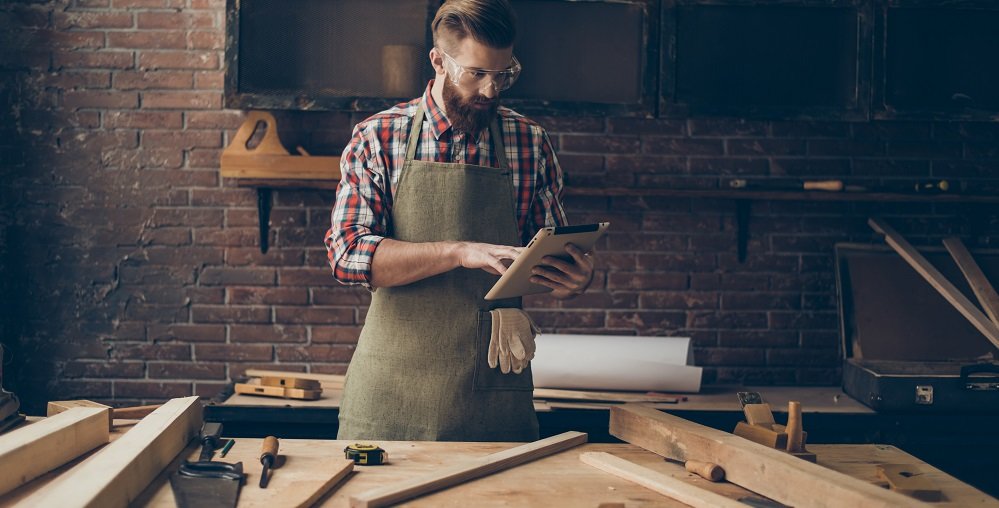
top-left (324, 126), bottom-right (388, 289)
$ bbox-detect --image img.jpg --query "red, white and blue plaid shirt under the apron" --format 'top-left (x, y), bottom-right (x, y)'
top-left (325, 81), bottom-right (567, 287)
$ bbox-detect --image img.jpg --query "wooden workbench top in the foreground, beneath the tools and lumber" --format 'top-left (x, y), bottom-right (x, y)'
top-left (136, 439), bottom-right (999, 508)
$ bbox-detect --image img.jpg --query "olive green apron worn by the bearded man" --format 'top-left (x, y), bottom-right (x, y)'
top-left (337, 106), bottom-right (538, 441)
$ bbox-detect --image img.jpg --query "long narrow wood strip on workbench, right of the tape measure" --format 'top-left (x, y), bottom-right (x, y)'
top-left (350, 432), bottom-right (586, 508)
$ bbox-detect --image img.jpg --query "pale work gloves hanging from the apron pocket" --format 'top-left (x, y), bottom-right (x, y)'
top-left (487, 308), bottom-right (538, 374)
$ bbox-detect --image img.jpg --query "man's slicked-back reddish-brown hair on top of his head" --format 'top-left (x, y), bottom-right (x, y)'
top-left (431, 0), bottom-right (517, 51)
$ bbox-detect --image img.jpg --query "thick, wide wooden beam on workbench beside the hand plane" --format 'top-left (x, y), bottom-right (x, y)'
top-left (610, 404), bottom-right (928, 508)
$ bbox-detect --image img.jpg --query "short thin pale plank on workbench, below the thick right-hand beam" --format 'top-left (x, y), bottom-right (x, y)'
top-left (579, 452), bottom-right (746, 508)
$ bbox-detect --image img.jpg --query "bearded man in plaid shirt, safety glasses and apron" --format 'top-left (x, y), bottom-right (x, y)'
top-left (325, 0), bottom-right (593, 441)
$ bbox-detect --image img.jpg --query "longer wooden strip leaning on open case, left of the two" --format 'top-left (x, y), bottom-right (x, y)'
top-left (867, 218), bottom-right (999, 348)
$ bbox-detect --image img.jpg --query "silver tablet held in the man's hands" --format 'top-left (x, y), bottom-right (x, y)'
top-left (485, 222), bottom-right (610, 300)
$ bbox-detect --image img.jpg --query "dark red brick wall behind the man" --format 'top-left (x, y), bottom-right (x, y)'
top-left (0, 0), bottom-right (999, 413)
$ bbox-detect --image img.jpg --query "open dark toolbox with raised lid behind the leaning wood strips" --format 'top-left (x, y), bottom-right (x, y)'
top-left (835, 244), bottom-right (999, 414)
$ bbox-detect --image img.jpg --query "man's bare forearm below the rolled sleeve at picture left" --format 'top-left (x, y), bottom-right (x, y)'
top-left (371, 238), bottom-right (460, 288)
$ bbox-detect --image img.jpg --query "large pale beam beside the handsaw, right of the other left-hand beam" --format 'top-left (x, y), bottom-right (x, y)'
top-left (25, 397), bottom-right (201, 508)
